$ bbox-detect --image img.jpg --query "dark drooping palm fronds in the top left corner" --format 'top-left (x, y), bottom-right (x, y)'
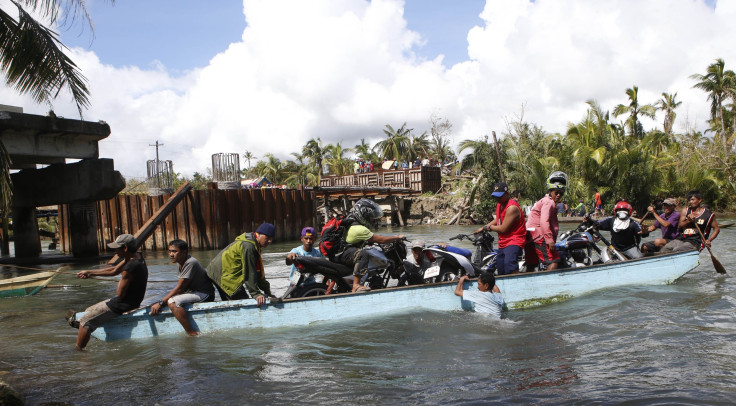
top-left (0, 0), bottom-right (94, 116)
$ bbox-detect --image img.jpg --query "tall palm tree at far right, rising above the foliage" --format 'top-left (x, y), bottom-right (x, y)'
top-left (690, 58), bottom-right (736, 142)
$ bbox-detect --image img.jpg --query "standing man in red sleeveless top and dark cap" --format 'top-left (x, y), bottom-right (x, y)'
top-left (474, 182), bottom-right (526, 275)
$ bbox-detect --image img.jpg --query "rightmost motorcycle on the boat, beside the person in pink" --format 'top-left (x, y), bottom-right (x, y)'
top-left (555, 218), bottom-right (625, 268)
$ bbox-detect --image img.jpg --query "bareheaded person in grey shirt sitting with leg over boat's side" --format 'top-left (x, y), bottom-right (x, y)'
top-left (150, 240), bottom-right (215, 336)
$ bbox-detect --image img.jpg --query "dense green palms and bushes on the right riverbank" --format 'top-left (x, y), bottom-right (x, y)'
top-left (472, 66), bottom-right (736, 213)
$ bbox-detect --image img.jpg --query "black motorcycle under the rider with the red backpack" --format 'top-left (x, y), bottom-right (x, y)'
top-left (283, 241), bottom-right (406, 298)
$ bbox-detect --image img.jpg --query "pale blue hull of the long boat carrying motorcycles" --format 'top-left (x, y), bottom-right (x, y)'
top-left (76, 250), bottom-right (699, 341)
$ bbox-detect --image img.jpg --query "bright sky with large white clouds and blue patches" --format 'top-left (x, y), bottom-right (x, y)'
top-left (0, 0), bottom-right (736, 178)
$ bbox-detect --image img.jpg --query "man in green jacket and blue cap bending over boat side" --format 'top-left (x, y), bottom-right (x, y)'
top-left (207, 223), bottom-right (276, 307)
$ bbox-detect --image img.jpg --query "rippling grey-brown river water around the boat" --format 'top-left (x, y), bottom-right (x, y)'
top-left (0, 225), bottom-right (736, 405)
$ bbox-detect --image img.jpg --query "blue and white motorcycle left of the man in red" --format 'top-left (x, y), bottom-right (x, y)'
top-left (399, 231), bottom-right (496, 286)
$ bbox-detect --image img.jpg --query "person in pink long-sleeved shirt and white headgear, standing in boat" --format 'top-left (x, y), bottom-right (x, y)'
top-left (526, 171), bottom-right (567, 271)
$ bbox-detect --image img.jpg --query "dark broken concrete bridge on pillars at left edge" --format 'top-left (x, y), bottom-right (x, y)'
top-left (0, 106), bottom-right (125, 258)
